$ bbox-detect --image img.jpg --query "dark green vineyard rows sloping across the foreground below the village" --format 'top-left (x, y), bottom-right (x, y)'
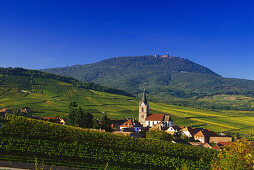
top-left (0, 114), bottom-right (217, 169)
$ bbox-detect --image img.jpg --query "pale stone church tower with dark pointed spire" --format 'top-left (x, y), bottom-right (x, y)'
top-left (138, 89), bottom-right (149, 126)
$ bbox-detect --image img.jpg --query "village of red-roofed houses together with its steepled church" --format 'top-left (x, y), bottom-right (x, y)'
top-left (0, 90), bottom-right (233, 150)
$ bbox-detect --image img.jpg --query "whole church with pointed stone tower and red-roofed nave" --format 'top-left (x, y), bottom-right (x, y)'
top-left (139, 90), bottom-right (173, 128)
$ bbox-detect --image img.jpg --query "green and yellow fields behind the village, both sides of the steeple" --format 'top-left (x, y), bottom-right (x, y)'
top-left (0, 76), bottom-right (254, 135)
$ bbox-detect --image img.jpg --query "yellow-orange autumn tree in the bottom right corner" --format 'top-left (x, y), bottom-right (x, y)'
top-left (212, 138), bottom-right (254, 169)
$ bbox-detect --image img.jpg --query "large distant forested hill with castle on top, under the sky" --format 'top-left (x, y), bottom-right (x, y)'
top-left (42, 56), bottom-right (254, 99)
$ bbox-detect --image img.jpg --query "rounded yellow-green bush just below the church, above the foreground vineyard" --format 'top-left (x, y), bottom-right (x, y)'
top-left (146, 130), bottom-right (173, 142)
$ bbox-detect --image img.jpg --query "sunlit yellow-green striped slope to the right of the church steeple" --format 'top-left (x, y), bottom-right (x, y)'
top-left (150, 103), bottom-right (254, 134)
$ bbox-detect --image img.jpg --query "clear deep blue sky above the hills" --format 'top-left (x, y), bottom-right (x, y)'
top-left (0, 0), bottom-right (254, 80)
